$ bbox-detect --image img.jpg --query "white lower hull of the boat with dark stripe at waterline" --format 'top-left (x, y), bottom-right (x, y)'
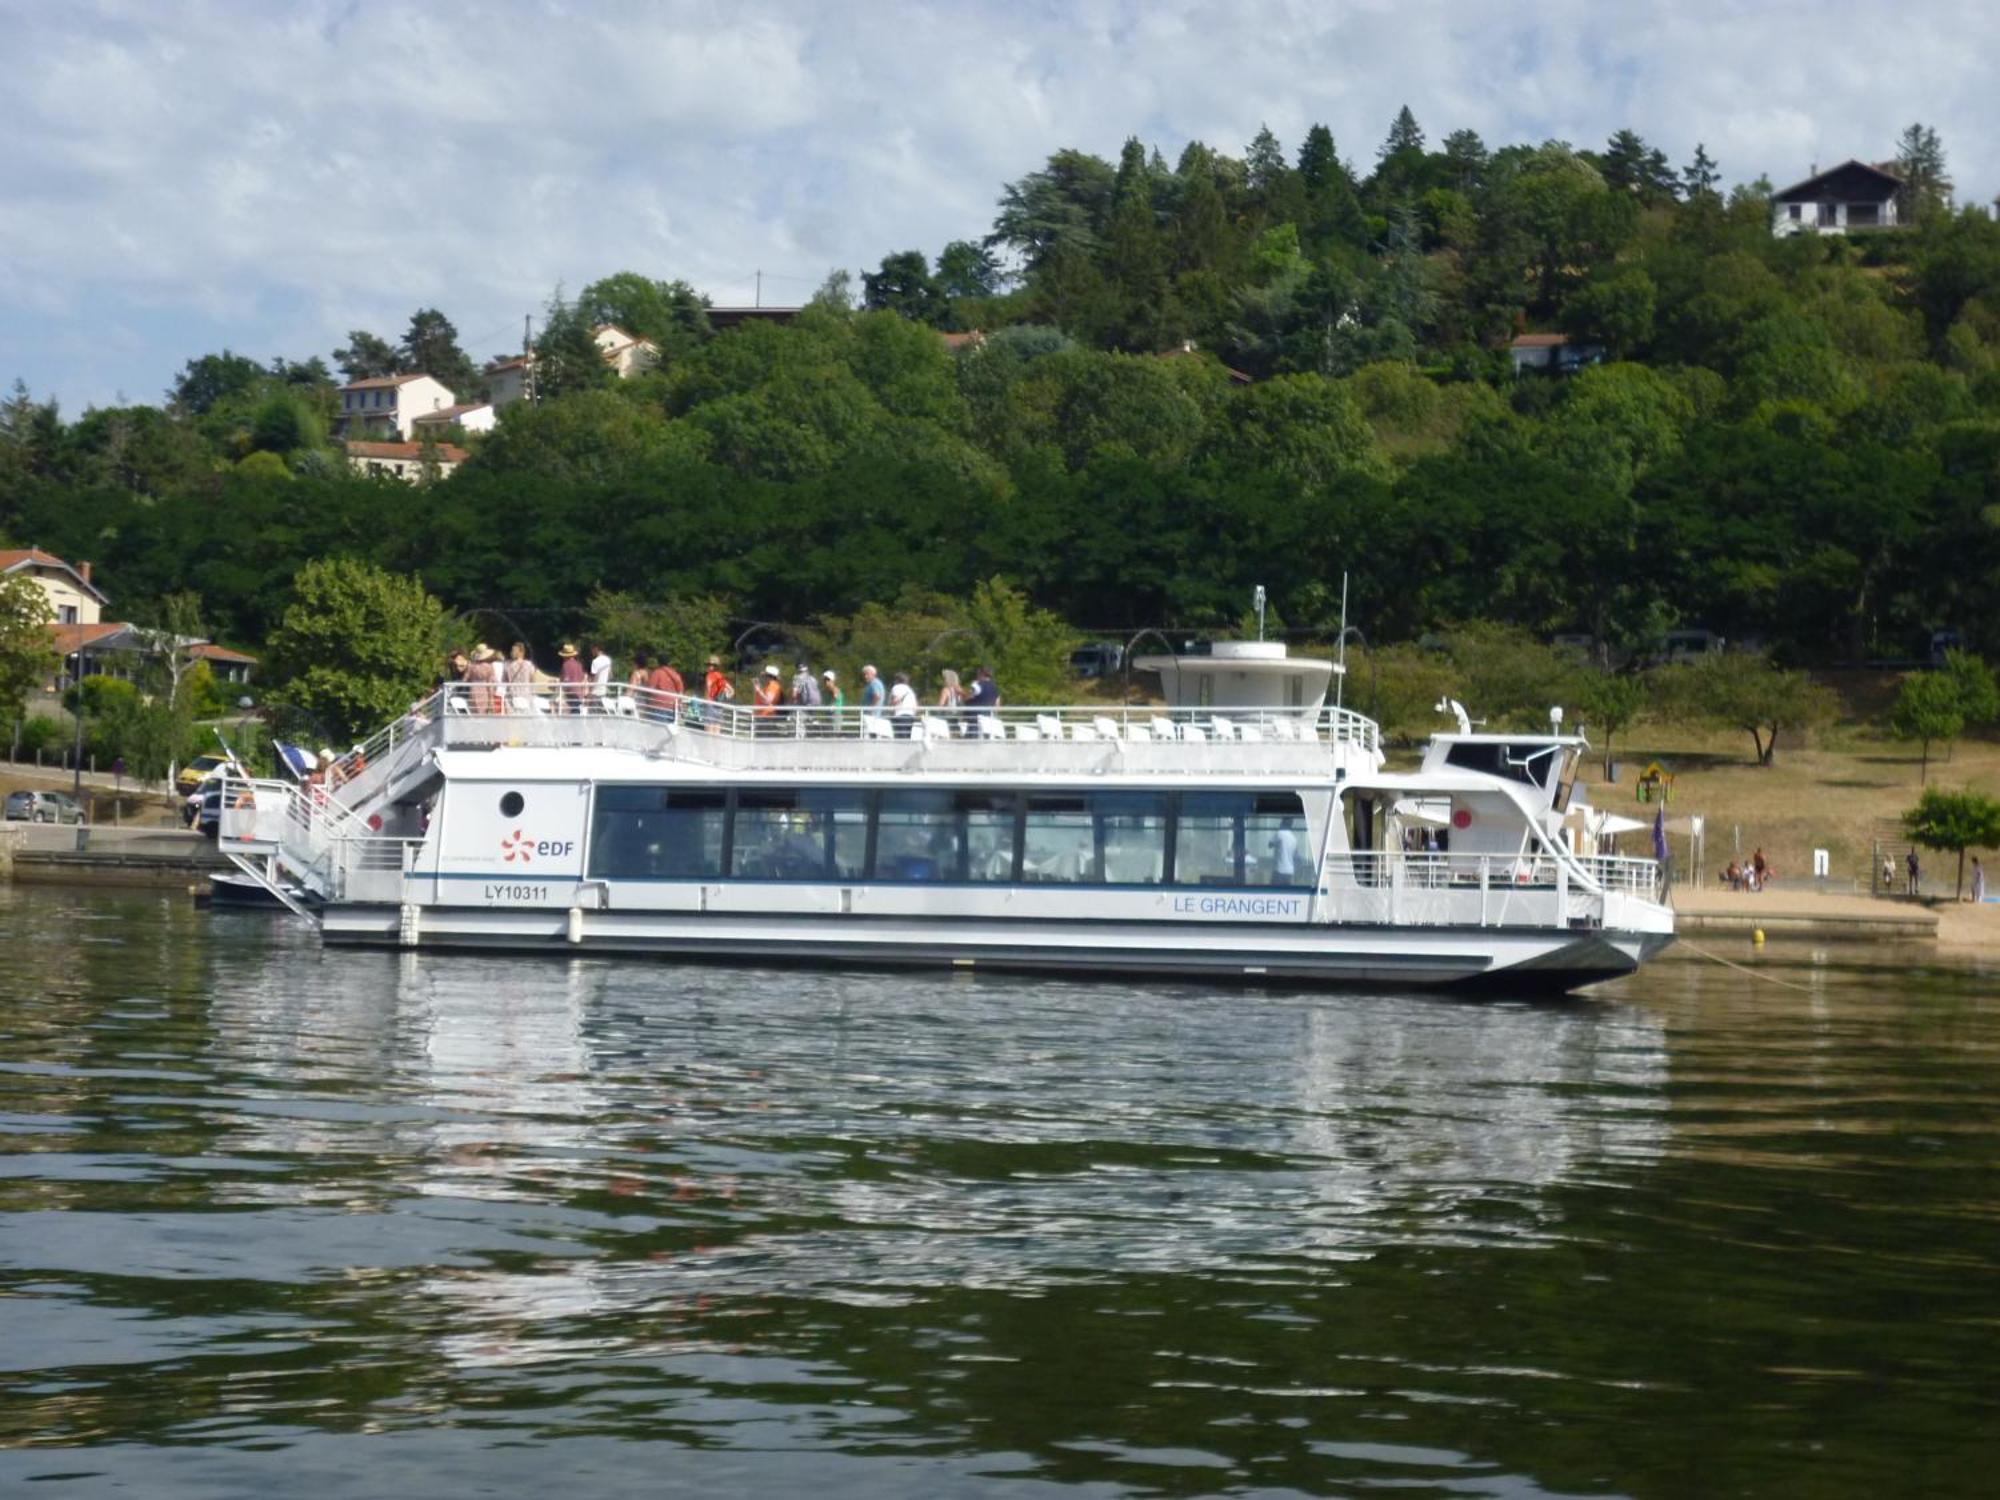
top-left (322, 906), bottom-right (1672, 994)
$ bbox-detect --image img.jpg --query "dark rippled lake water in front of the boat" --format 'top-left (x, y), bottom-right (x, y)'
top-left (0, 888), bottom-right (2000, 1496)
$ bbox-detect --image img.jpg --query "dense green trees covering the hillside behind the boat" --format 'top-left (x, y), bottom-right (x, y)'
top-left (0, 112), bottom-right (2000, 680)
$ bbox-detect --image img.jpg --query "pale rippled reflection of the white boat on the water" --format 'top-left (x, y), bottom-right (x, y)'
top-left (207, 954), bottom-right (1666, 1364)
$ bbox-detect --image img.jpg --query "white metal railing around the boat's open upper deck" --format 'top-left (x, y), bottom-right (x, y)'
top-left (324, 682), bottom-right (1382, 802)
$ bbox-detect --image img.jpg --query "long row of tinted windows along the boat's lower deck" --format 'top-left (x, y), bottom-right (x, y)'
top-left (590, 786), bottom-right (1316, 886)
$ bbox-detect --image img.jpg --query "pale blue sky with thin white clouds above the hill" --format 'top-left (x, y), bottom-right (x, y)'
top-left (0, 0), bottom-right (2000, 416)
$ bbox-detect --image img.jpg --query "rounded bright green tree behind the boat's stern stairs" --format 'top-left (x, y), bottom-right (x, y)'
top-left (266, 558), bottom-right (446, 744)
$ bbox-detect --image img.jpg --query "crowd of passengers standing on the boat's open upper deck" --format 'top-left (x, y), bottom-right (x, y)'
top-left (438, 640), bottom-right (1000, 738)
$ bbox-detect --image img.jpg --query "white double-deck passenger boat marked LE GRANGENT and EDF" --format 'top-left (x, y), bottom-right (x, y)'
top-left (220, 648), bottom-right (1672, 990)
